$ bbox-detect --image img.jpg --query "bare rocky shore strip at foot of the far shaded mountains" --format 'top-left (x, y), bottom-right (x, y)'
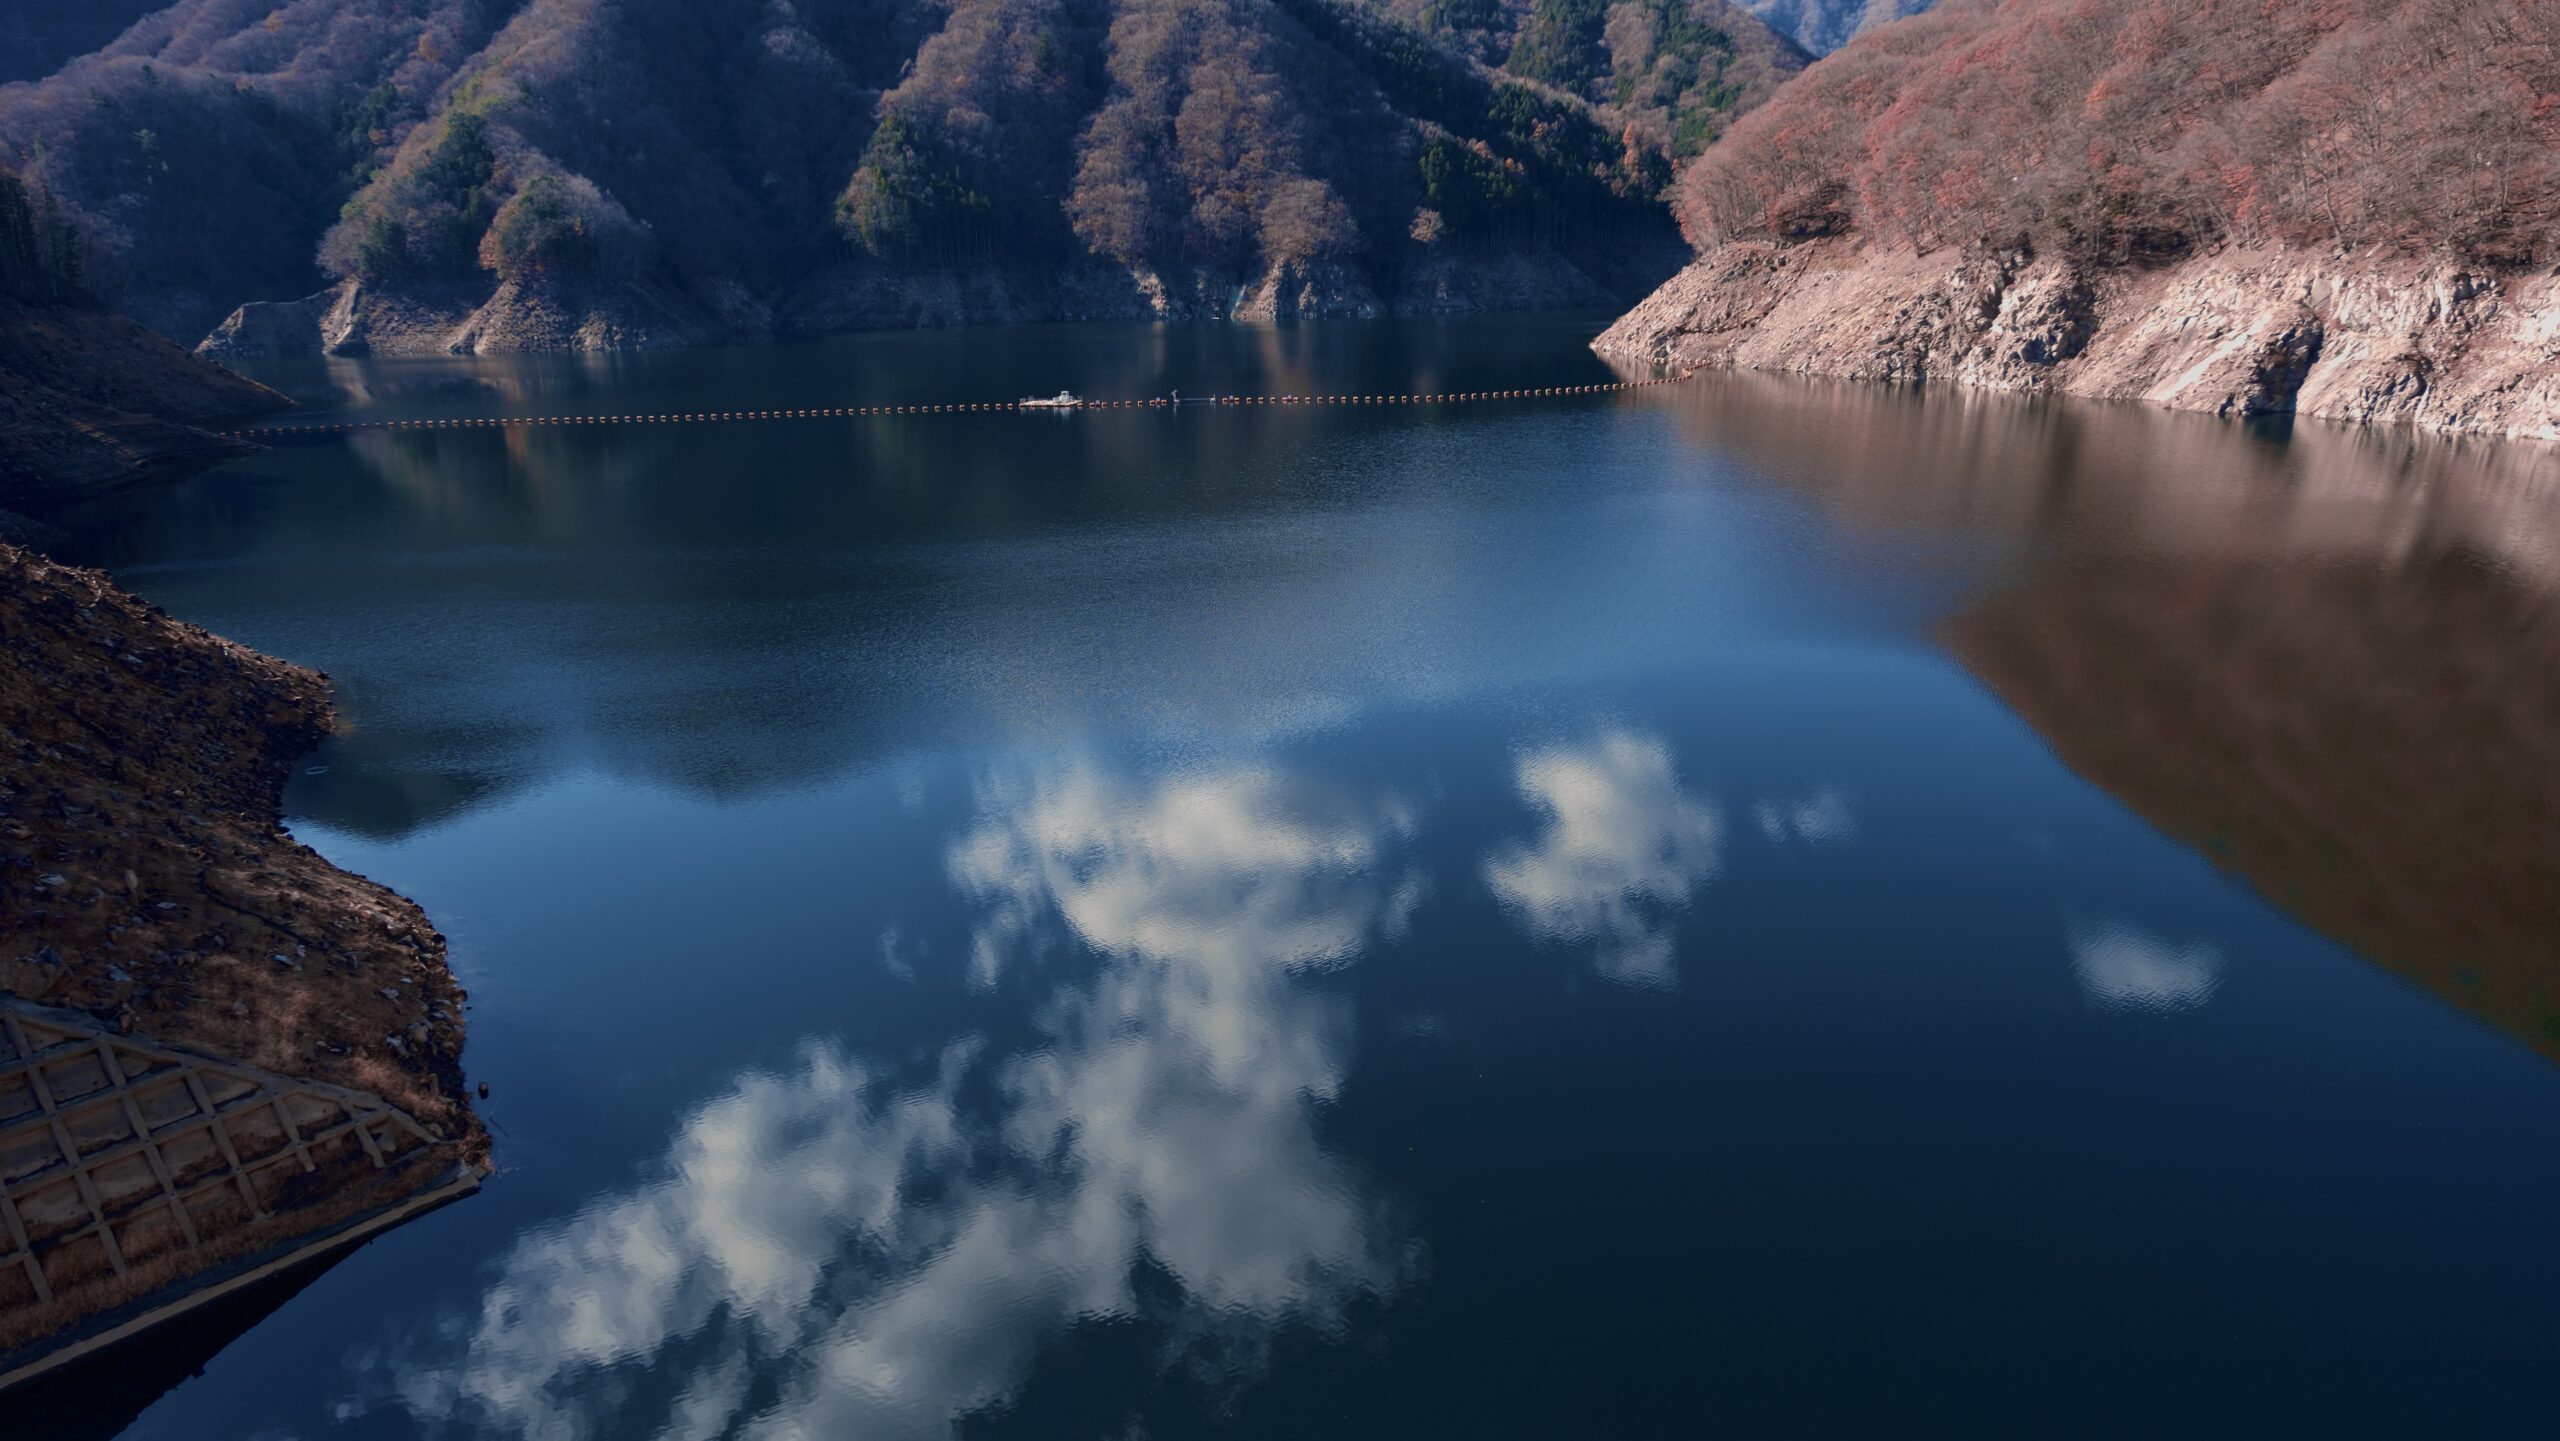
top-left (197, 253), bottom-right (1607, 358)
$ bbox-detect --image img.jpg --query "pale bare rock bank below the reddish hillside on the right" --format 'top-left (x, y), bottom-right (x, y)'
top-left (1592, 241), bottom-right (2560, 440)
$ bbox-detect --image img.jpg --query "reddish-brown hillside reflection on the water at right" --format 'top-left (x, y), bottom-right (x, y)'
top-left (1648, 376), bottom-right (2560, 1060)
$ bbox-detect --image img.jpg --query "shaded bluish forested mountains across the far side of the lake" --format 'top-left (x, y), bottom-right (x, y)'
top-left (0, 0), bottom-right (1802, 348)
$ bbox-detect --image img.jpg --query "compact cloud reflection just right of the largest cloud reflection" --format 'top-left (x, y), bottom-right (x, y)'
top-left (1485, 729), bottom-right (1723, 988)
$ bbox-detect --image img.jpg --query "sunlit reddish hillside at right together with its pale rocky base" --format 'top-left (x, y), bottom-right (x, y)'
top-left (1603, 0), bottom-right (2560, 438)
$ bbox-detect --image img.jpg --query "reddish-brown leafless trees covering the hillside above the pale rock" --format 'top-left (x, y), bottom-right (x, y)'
top-left (1679, 0), bottom-right (2560, 264)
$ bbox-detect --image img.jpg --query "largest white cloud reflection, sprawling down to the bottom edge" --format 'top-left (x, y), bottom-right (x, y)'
top-left (376, 768), bottom-right (1418, 1438)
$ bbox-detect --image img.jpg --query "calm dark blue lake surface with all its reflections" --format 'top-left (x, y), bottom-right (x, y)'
top-left (35, 317), bottom-right (2560, 1441)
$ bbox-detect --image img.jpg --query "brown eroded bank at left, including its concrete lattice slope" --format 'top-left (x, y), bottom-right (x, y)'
top-left (0, 545), bottom-right (489, 1359)
